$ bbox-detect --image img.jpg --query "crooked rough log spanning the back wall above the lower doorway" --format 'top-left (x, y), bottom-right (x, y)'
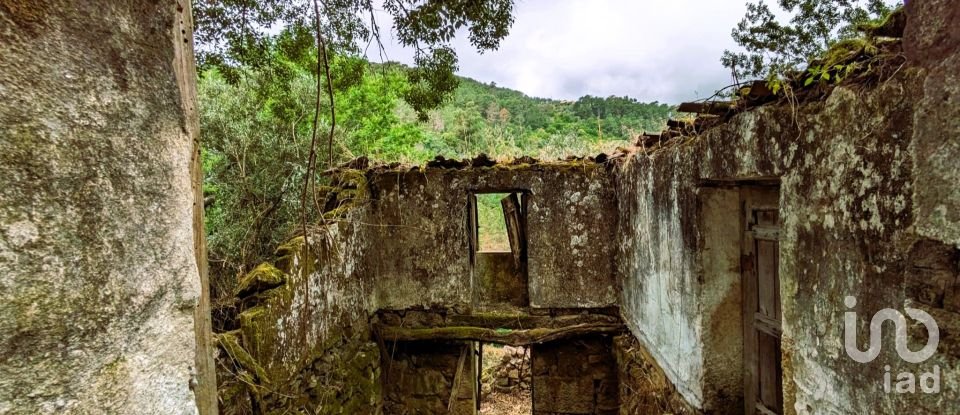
top-left (376, 323), bottom-right (626, 346)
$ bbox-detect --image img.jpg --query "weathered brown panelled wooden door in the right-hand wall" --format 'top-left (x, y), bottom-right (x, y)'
top-left (741, 187), bottom-right (783, 415)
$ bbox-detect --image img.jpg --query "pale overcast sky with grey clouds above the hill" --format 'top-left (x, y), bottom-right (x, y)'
top-left (371, 0), bottom-right (746, 104)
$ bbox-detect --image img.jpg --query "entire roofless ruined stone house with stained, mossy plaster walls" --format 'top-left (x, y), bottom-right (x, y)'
top-left (0, 0), bottom-right (960, 415)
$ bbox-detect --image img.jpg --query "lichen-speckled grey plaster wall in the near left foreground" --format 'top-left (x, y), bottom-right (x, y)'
top-left (0, 0), bottom-right (200, 414)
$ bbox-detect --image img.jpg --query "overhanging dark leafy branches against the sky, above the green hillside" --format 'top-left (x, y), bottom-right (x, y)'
top-left (194, 0), bottom-right (513, 120)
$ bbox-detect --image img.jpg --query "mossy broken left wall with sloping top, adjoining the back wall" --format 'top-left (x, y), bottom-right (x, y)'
top-left (218, 212), bottom-right (381, 414)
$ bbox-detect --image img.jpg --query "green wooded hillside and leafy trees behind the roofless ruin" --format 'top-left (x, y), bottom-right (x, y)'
top-left (199, 52), bottom-right (672, 280)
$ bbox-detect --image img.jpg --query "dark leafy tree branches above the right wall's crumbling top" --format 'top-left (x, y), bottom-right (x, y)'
top-left (721, 0), bottom-right (897, 81)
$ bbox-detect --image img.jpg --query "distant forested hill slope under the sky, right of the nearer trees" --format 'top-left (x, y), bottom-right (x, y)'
top-left (408, 77), bottom-right (673, 158)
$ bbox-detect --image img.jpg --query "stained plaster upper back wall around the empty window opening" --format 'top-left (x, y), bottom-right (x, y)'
top-left (360, 161), bottom-right (617, 309)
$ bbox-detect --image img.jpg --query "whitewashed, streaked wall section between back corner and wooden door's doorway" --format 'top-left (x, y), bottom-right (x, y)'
top-left (617, 152), bottom-right (703, 405)
